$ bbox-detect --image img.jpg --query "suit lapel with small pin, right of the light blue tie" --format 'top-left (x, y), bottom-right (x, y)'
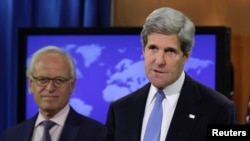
top-left (166, 75), bottom-right (202, 141)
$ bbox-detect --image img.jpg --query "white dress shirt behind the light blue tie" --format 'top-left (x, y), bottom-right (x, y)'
top-left (141, 71), bottom-right (185, 141)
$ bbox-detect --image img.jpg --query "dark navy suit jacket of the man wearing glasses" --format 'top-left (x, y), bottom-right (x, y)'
top-left (1, 108), bottom-right (104, 141)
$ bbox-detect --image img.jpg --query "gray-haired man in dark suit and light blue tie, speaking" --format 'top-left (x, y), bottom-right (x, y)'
top-left (105, 7), bottom-right (237, 141)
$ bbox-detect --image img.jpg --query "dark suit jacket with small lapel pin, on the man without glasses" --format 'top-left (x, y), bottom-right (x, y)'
top-left (102, 74), bottom-right (237, 141)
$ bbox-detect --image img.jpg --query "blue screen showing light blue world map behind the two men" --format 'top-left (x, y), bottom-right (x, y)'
top-left (26, 35), bottom-right (216, 123)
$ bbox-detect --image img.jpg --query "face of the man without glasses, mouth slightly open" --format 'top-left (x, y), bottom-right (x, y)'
top-left (143, 33), bottom-right (190, 89)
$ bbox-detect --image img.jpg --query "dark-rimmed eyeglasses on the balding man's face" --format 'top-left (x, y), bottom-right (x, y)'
top-left (32, 75), bottom-right (71, 88)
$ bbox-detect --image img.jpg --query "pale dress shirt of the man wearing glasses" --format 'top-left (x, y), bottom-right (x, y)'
top-left (31, 105), bottom-right (70, 141)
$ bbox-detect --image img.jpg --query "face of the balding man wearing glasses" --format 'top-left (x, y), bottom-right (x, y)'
top-left (28, 53), bottom-right (75, 116)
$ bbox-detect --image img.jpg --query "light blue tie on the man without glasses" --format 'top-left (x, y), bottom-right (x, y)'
top-left (144, 91), bottom-right (165, 141)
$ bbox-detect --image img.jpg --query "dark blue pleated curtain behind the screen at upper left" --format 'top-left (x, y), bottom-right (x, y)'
top-left (0, 0), bottom-right (111, 133)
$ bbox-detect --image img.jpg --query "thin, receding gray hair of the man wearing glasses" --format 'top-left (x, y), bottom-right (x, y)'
top-left (26, 46), bottom-right (76, 79)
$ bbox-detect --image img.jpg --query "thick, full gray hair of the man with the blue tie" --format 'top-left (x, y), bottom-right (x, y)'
top-left (141, 7), bottom-right (195, 54)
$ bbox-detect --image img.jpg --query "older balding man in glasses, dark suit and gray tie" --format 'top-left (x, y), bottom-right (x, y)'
top-left (1, 46), bottom-right (105, 141)
